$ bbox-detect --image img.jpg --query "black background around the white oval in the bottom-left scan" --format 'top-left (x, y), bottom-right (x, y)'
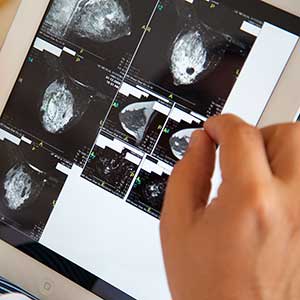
top-left (0, 140), bottom-right (67, 240)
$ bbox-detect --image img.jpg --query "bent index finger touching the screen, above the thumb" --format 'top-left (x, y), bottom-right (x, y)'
top-left (204, 115), bottom-right (272, 183)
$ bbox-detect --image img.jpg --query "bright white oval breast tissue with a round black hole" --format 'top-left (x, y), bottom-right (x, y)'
top-left (171, 31), bottom-right (207, 85)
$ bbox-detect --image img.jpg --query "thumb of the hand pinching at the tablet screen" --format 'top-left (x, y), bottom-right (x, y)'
top-left (161, 130), bottom-right (215, 230)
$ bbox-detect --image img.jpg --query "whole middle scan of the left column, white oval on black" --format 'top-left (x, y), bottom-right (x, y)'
top-left (1, 49), bottom-right (117, 162)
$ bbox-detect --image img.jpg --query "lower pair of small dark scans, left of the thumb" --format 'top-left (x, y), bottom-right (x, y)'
top-left (81, 133), bottom-right (173, 218)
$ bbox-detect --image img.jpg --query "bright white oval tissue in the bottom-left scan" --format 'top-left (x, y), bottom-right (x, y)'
top-left (4, 165), bottom-right (32, 210)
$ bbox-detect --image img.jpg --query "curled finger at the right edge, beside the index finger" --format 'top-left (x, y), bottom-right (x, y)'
top-left (261, 123), bottom-right (300, 182)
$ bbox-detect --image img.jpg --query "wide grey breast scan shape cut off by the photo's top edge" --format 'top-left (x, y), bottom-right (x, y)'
top-left (45, 0), bottom-right (131, 43)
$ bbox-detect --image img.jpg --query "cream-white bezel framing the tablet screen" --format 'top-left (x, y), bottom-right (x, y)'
top-left (0, 0), bottom-right (300, 300)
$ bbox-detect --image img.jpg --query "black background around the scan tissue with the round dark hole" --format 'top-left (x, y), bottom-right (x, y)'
top-left (129, 0), bottom-right (255, 116)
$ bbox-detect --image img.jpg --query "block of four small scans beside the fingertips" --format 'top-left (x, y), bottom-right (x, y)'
top-left (82, 89), bottom-right (205, 218)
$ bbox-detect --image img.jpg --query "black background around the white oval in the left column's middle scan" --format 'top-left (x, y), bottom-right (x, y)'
top-left (1, 49), bottom-right (117, 165)
